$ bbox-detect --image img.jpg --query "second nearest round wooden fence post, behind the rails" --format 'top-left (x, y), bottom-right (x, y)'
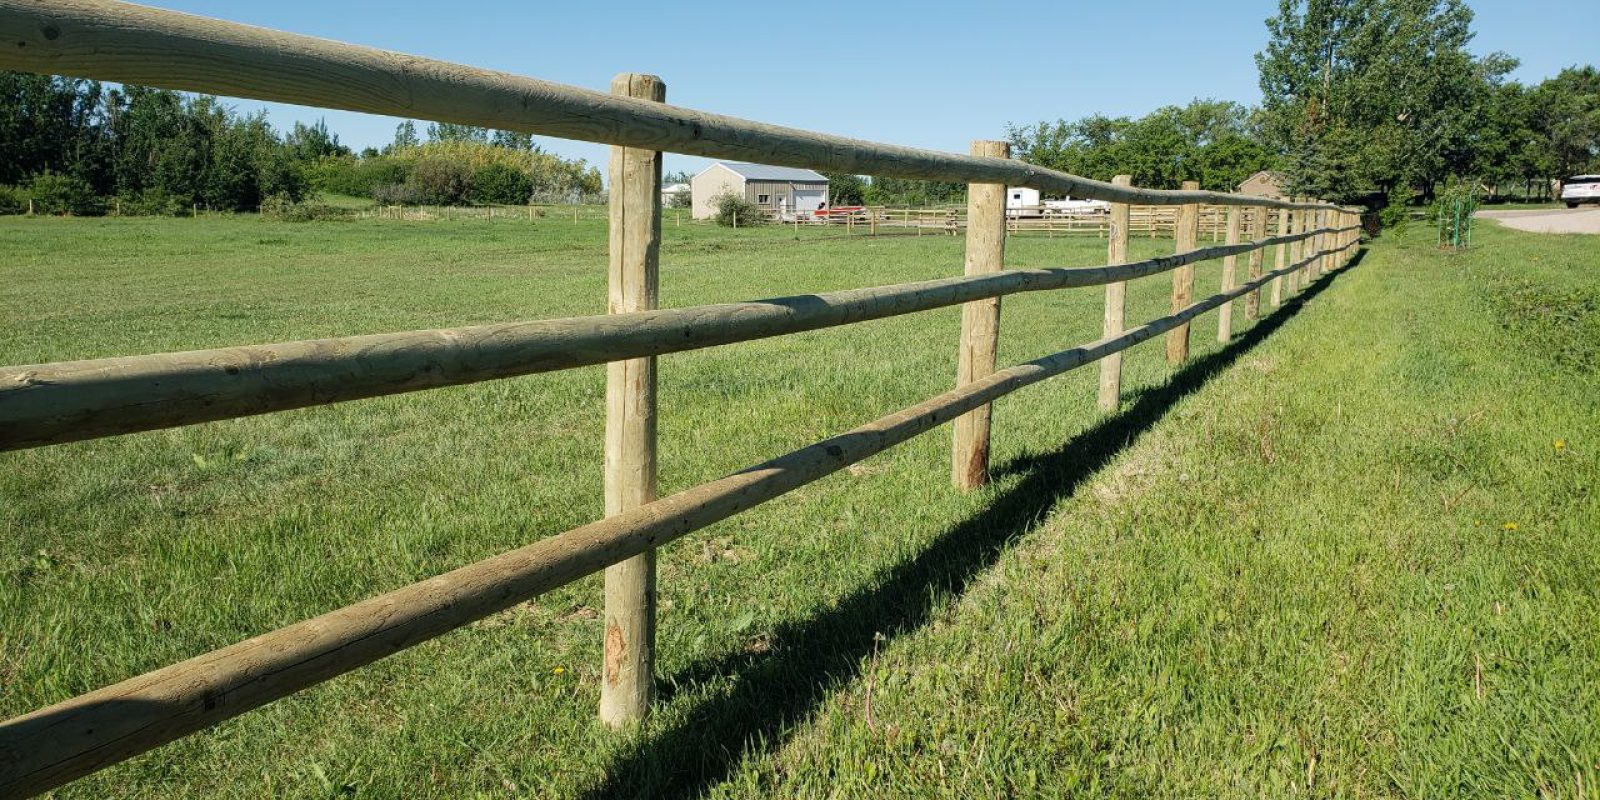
top-left (950, 139), bottom-right (1011, 490)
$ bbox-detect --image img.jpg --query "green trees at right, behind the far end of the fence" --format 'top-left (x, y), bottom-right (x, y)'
top-left (1010, 0), bottom-right (1600, 216)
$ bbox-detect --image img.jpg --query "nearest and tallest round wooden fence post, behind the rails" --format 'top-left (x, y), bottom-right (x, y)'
top-left (601, 72), bottom-right (667, 728)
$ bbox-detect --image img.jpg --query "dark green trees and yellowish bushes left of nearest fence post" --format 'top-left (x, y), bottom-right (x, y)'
top-left (0, 72), bottom-right (602, 214)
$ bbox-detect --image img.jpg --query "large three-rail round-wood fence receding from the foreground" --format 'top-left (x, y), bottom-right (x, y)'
top-left (0, 0), bottom-right (1358, 797)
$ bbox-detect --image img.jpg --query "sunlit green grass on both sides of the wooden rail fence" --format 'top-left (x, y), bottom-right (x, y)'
top-left (0, 218), bottom-right (1600, 797)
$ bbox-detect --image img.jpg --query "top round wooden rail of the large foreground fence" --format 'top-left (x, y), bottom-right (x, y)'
top-left (0, 0), bottom-right (1339, 210)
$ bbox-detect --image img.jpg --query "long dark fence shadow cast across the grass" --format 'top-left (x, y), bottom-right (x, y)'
top-left (586, 250), bottom-right (1365, 798)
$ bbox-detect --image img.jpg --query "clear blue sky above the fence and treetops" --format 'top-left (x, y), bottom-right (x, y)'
top-left (146, 0), bottom-right (1600, 180)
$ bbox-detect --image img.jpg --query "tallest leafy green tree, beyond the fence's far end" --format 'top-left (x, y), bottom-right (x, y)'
top-left (1256, 0), bottom-right (1515, 202)
